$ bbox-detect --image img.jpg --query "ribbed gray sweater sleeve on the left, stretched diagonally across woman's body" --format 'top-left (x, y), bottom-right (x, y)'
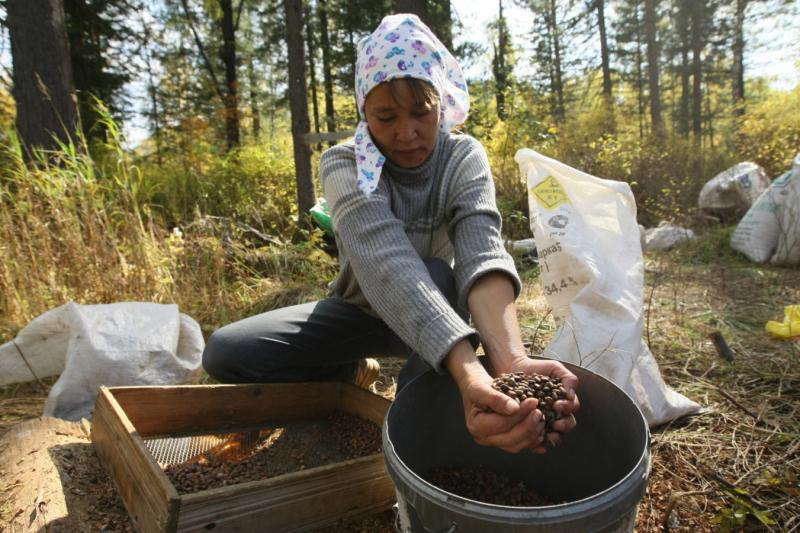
top-left (320, 145), bottom-right (476, 372)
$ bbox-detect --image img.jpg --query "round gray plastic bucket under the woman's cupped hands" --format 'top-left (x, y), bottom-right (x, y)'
top-left (383, 364), bottom-right (650, 533)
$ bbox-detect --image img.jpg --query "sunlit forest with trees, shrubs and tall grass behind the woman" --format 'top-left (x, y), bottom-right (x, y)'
top-left (0, 0), bottom-right (800, 341)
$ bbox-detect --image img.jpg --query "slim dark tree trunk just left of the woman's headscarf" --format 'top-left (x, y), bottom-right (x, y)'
top-left (283, 0), bottom-right (314, 228)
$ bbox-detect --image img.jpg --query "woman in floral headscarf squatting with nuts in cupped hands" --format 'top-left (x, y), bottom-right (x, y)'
top-left (203, 14), bottom-right (579, 453)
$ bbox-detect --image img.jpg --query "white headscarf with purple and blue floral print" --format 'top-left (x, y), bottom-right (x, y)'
top-left (355, 14), bottom-right (469, 195)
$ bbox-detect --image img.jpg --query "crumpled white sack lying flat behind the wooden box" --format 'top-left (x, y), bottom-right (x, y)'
top-left (0, 302), bottom-right (205, 420)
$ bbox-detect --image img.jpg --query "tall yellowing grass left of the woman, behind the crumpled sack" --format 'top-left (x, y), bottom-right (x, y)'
top-left (0, 106), bottom-right (335, 341)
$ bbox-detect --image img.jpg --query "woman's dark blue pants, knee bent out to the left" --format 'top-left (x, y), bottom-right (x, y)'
top-left (203, 259), bottom-right (469, 390)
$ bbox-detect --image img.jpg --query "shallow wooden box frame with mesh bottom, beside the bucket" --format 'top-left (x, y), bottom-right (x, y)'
top-left (92, 382), bottom-right (396, 532)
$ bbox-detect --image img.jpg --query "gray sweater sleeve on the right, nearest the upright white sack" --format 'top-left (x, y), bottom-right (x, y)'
top-left (447, 136), bottom-right (522, 309)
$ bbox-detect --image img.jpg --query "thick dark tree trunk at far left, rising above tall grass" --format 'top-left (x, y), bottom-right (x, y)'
top-left (5, 0), bottom-right (78, 158)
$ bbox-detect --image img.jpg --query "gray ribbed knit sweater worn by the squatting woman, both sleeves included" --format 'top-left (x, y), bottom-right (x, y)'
top-left (320, 133), bottom-right (520, 372)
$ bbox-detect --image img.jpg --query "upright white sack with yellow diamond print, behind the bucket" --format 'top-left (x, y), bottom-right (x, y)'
top-left (515, 149), bottom-right (700, 426)
